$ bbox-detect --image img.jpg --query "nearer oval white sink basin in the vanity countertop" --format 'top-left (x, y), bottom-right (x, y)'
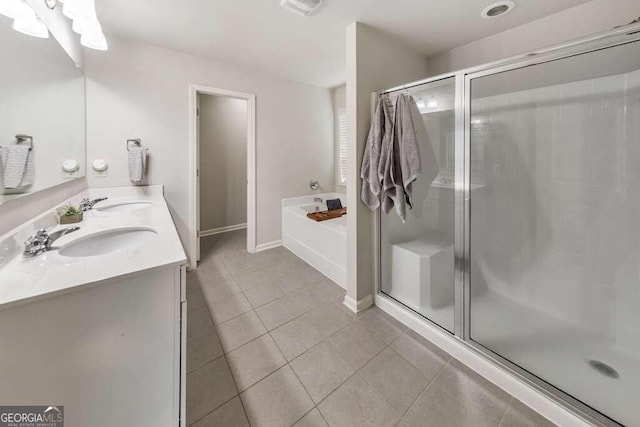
top-left (58, 227), bottom-right (157, 257)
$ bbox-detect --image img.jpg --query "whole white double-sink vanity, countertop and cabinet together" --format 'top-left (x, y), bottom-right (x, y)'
top-left (0, 186), bottom-right (186, 427)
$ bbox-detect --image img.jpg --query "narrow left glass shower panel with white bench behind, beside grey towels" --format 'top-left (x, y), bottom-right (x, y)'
top-left (380, 77), bottom-right (456, 333)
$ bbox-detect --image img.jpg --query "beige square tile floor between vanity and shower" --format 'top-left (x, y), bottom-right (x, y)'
top-left (187, 231), bottom-right (553, 427)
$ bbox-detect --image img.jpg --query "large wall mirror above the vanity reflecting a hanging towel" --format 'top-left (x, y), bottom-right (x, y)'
top-left (0, 15), bottom-right (86, 204)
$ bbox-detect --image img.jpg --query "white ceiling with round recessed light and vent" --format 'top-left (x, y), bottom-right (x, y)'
top-left (96, 0), bottom-right (588, 87)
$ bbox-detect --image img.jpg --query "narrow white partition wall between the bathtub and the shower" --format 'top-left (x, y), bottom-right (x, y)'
top-left (346, 22), bottom-right (428, 310)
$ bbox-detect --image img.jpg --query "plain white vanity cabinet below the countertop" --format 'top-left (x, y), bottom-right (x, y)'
top-left (0, 265), bottom-right (186, 427)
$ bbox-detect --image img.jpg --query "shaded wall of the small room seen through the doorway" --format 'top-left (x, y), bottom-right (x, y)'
top-left (198, 94), bottom-right (248, 231)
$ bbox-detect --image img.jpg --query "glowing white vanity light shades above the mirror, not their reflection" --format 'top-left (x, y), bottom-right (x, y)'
top-left (44, 0), bottom-right (109, 50)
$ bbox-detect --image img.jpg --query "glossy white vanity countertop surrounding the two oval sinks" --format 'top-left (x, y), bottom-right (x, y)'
top-left (0, 186), bottom-right (187, 308)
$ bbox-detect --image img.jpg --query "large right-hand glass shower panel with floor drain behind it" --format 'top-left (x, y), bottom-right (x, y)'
top-left (468, 42), bottom-right (640, 426)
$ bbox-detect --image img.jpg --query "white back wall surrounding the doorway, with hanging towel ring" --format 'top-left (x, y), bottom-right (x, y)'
top-left (85, 38), bottom-right (334, 249)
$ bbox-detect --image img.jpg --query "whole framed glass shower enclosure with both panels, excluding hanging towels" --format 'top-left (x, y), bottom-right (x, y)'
top-left (377, 25), bottom-right (640, 426)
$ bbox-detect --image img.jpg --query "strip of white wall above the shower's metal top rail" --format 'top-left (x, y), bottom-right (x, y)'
top-left (429, 0), bottom-right (640, 75)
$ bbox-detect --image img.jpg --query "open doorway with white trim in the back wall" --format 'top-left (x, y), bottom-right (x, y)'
top-left (188, 85), bottom-right (256, 268)
